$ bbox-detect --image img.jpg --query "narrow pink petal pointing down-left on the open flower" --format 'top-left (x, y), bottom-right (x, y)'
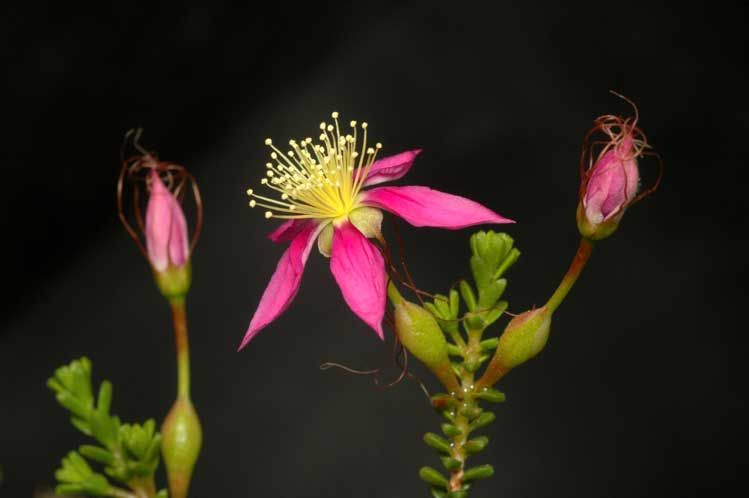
top-left (239, 223), bottom-right (319, 349)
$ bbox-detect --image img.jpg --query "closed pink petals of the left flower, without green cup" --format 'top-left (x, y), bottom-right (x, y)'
top-left (146, 169), bottom-right (189, 272)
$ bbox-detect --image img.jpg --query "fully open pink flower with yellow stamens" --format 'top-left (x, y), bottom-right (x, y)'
top-left (240, 112), bottom-right (513, 349)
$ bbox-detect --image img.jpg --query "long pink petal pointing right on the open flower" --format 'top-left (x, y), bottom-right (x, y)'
top-left (360, 186), bottom-right (515, 230)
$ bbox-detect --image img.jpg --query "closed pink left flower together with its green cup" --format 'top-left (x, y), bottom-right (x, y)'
top-left (146, 170), bottom-right (191, 297)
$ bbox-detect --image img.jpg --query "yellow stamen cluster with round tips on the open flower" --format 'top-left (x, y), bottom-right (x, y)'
top-left (247, 112), bottom-right (382, 223)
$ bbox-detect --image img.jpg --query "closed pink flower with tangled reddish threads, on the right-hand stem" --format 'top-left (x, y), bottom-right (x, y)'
top-left (577, 108), bottom-right (647, 240)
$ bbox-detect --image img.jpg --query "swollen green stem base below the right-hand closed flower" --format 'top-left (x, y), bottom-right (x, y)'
top-left (477, 307), bottom-right (552, 390)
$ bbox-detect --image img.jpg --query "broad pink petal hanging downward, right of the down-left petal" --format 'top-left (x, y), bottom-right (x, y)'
top-left (330, 222), bottom-right (387, 339)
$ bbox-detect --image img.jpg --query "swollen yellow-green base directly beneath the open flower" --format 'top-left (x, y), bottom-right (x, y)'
top-left (388, 282), bottom-right (460, 392)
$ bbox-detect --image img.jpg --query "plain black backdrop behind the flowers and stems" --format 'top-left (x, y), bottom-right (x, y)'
top-left (0, 2), bottom-right (748, 498)
